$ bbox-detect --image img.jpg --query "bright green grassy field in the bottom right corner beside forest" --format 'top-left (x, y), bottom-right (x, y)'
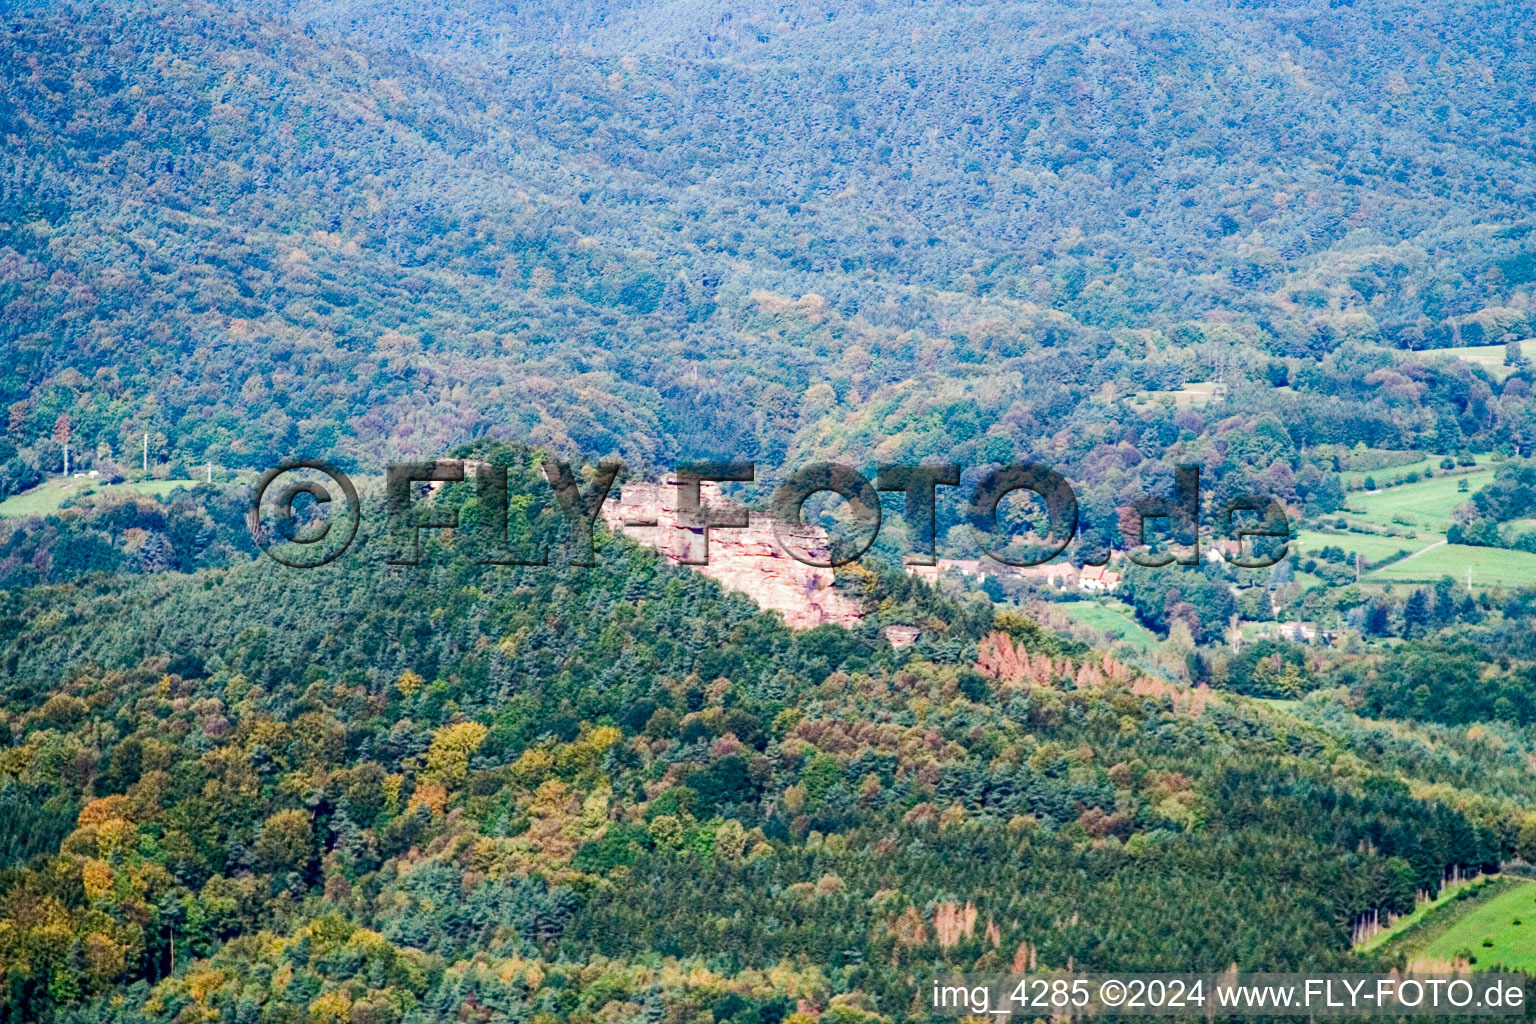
top-left (1381, 877), bottom-right (1536, 970)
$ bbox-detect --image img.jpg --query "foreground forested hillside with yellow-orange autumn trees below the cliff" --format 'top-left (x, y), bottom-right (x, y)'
top-left (0, 451), bottom-right (1536, 1022)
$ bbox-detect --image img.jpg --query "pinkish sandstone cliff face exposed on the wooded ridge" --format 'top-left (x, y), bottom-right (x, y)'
top-left (602, 479), bottom-right (863, 629)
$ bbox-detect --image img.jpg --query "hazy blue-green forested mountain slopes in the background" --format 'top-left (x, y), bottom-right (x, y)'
top-left (0, 3), bottom-right (1536, 521)
